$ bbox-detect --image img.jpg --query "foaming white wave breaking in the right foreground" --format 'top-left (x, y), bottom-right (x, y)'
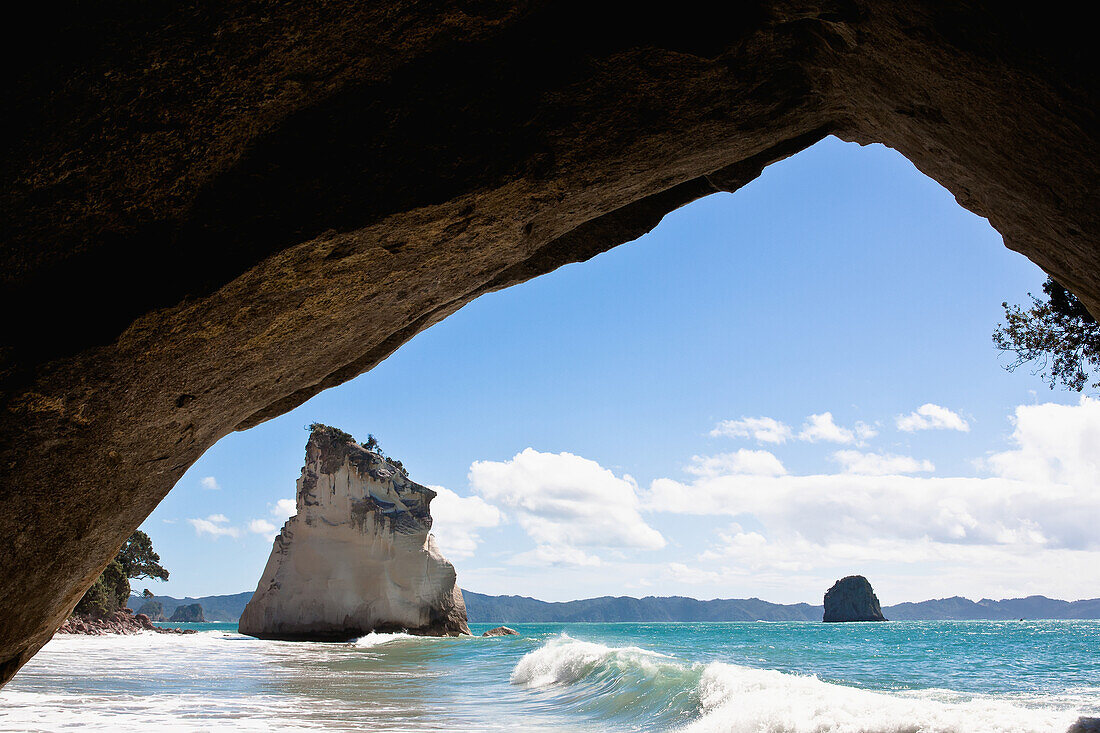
top-left (512, 634), bottom-right (1078, 733)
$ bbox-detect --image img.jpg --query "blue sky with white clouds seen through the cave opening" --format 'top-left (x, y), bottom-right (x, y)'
top-left (135, 139), bottom-right (1100, 603)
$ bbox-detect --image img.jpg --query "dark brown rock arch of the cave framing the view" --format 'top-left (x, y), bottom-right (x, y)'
top-left (0, 0), bottom-right (1100, 680)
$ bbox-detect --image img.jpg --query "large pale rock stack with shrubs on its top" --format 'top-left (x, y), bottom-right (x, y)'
top-left (240, 425), bottom-right (470, 641)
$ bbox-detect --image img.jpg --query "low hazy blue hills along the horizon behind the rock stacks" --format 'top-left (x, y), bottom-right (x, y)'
top-left (130, 590), bottom-right (1100, 624)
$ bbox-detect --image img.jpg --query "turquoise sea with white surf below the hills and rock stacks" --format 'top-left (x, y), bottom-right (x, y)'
top-left (0, 621), bottom-right (1100, 733)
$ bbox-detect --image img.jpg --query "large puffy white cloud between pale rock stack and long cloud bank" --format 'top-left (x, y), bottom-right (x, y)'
top-left (470, 448), bottom-right (664, 553)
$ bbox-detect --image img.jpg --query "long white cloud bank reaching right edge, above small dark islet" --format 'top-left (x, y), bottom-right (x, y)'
top-left (645, 397), bottom-right (1100, 557)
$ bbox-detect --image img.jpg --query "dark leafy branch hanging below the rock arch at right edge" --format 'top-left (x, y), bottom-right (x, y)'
top-left (993, 277), bottom-right (1100, 392)
